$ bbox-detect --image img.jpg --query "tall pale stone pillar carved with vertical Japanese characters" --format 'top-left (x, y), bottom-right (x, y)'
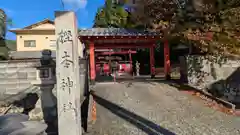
top-left (55, 11), bottom-right (82, 135)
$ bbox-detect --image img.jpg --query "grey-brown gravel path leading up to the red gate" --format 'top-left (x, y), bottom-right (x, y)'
top-left (85, 82), bottom-right (240, 135)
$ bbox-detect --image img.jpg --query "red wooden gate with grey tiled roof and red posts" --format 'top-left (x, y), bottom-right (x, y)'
top-left (79, 28), bottom-right (170, 82)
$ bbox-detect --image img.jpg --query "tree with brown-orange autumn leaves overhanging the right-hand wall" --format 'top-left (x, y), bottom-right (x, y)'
top-left (134, 0), bottom-right (240, 56)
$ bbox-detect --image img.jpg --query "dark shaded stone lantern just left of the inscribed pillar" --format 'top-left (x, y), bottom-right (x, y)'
top-left (38, 50), bottom-right (57, 126)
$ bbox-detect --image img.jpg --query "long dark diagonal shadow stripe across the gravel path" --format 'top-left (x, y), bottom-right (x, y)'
top-left (92, 93), bottom-right (175, 135)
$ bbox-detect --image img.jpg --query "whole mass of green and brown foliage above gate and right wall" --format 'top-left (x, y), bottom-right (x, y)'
top-left (94, 0), bottom-right (240, 57)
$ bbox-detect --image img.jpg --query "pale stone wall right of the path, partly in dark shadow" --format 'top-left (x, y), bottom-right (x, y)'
top-left (186, 56), bottom-right (240, 104)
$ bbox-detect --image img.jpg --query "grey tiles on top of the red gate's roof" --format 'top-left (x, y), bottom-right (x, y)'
top-left (79, 28), bottom-right (162, 37)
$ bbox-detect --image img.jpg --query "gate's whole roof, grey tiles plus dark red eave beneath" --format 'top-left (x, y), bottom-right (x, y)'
top-left (79, 28), bottom-right (163, 44)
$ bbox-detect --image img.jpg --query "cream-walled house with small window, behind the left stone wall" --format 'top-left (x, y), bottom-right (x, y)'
top-left (10, 19), bottom-right (56, 52)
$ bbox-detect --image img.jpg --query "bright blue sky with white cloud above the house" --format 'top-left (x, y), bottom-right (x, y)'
top-left (0, 0), bottom-right (105, 39)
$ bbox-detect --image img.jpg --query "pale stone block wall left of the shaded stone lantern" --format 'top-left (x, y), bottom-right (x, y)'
top-left (0, 61), bottom-right (39, 104)
